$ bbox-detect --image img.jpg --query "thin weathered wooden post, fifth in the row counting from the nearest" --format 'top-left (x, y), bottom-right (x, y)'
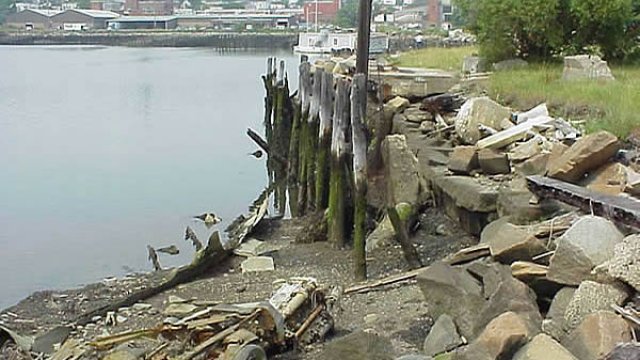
top-left (296, 61), bottom-right (312, 216)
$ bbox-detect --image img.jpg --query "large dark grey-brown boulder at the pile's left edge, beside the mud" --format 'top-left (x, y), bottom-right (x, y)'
top-left (416, 262), bottom-right (485, 339)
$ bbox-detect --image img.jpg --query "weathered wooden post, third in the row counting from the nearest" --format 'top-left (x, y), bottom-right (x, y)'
top-left (315, 72), bottom-right (335, 210)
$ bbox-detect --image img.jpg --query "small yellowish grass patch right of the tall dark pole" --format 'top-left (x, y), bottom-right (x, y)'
top-left (398, 46), bottom-right (478, 71)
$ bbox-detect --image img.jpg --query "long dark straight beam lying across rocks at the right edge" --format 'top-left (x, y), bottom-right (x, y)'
top-left (527, 175), bottom-right (640, 229)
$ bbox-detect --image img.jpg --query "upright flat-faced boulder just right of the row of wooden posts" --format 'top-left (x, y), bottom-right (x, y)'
top-left (382, 135), bottom-right (420, 205)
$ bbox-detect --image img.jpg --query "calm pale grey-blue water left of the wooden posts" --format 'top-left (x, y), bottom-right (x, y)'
top-left (0, 47), bottom-right (296, 309)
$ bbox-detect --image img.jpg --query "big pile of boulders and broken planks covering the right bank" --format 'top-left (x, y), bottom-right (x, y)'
top-left (376, 90), bottom-right (640, 360)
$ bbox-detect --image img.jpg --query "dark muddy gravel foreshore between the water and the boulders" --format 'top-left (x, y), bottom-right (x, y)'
top-left (0, 208), bottom-right (476, 359)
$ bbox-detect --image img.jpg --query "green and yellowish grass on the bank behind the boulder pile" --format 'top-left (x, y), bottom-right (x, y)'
top-left (399, 48), bottom-right (640, 138)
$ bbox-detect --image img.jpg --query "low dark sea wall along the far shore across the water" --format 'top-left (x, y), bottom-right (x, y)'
top-left (0, 31), bottom-right (298, 50)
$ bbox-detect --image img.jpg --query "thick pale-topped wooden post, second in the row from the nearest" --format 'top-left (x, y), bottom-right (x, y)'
top-left (327, 79), bottom-right (351, 248)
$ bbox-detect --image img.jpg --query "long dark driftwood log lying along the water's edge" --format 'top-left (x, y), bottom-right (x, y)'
top-left (75, 189), bottom-right (271, 325)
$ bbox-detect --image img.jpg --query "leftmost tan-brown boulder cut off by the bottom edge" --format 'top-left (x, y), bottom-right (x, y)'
top-left (455, 312), bottom-right (535, 360)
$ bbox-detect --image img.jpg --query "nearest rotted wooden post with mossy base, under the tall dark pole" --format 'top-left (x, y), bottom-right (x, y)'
top-left (351, 74), bottom-right (367, 281)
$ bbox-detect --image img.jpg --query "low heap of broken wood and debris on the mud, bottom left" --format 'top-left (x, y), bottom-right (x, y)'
top-left (0, 278), bottom-right (336, 360)
